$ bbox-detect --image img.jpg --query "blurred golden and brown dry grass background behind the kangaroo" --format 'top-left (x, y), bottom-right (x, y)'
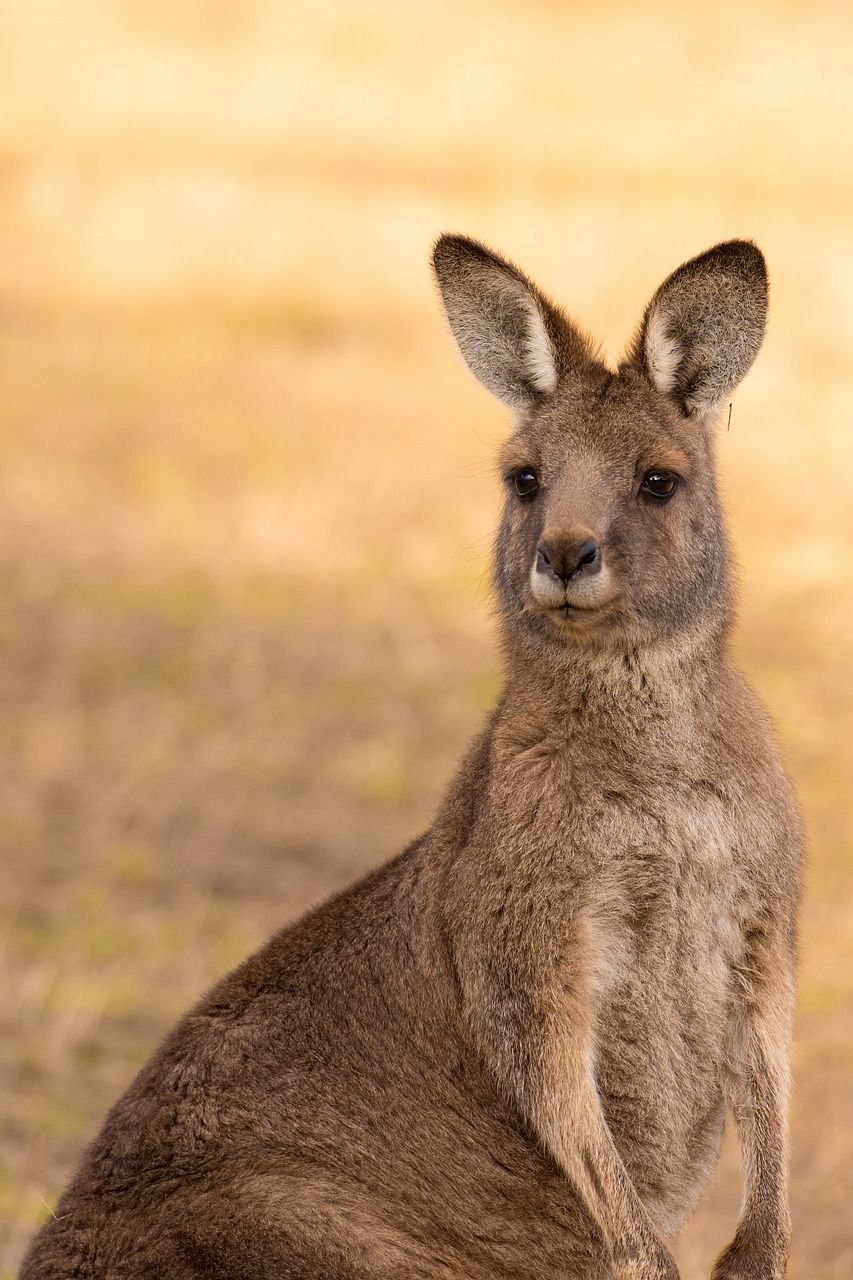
top-left (0, 0), bottom-right (853, 1280)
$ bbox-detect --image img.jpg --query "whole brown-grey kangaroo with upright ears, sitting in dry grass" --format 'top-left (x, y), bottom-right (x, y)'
top-left (20, 236), bottom-right (802, 1280)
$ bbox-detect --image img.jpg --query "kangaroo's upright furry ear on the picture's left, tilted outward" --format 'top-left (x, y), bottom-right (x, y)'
top-left (433, 236), bottom-right (592, 408)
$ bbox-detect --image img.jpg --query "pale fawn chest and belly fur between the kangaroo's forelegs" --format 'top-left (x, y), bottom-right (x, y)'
top-left (573, 785), bottom-right (742, 1224)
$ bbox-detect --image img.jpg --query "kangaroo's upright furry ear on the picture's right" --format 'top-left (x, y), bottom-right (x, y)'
top-left (629, 241), bottom-right (767, 419)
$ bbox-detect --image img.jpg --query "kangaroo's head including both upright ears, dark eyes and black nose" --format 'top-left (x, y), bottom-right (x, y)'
top-left (433, 236), bottom-right (767, 652)
